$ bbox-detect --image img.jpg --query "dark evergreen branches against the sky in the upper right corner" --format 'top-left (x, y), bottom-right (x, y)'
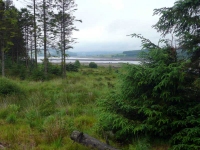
top-left (153, 0), bottom-right (200, 67)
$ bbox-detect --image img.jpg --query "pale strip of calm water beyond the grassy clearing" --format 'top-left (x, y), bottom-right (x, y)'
top-left (38, 57), bottom-right (140, 64)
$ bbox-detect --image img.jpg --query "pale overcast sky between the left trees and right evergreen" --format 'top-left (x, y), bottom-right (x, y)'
top-left (14, 0), bottom-right (176, 51)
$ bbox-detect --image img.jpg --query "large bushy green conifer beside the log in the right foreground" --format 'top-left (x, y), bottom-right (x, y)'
top-left (98, 34), bottom-right (200, 150)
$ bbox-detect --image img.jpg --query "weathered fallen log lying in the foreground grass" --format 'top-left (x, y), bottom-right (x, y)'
top-left (70, 131), bottom-right (118, 150)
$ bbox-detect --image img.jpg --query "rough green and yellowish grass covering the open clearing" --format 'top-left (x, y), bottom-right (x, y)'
top-left (0, 67), bottom-right (117, 150)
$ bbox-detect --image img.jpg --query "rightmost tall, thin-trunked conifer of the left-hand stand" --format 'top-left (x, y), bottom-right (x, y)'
top-left (54, 0), bottom-right (81, 78)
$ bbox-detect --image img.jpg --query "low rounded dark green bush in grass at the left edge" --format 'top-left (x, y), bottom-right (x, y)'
top-left (0, 78), bottom-right (23, 95)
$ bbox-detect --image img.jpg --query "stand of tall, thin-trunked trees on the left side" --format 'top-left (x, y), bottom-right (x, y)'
top-left (0, 0), bottom-right (81, 77)
